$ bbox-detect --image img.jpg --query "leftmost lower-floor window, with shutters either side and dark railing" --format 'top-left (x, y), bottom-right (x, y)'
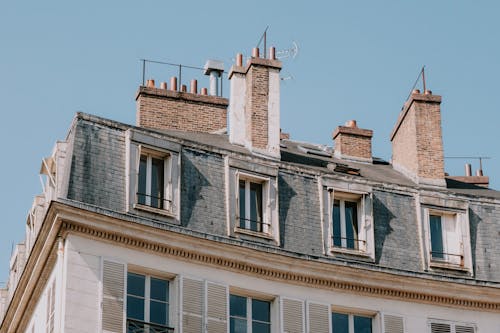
top-left (127, 272), bottom-right (173, 333)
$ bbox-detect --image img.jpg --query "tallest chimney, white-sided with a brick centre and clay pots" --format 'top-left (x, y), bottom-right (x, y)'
top-left (229, 48), bottom-right (281, 158)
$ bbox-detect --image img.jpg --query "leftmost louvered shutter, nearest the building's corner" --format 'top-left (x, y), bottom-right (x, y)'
top-left (102, 260), bottom-right (125, 333)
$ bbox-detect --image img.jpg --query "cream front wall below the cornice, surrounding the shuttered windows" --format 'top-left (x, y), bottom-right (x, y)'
top-left (62, 235), bottom-right (500, 333)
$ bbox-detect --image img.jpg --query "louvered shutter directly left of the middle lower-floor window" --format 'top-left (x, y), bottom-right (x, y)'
top-left (206, 282), bottom-right (228, 333)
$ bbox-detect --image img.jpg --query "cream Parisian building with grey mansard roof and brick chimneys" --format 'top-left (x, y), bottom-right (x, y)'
top-left (0, 49), bottom-right (500, 333)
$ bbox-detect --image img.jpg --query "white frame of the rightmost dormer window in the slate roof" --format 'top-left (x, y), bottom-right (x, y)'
top-left (422, 205), bottom-right (472, 274)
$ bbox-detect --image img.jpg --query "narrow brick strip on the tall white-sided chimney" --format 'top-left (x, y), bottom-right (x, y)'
top-left (246, 65), bottom-right (269, 149)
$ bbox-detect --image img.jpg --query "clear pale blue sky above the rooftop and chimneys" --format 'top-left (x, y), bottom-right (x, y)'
top-left (0, 0), bottom-right (500, 282)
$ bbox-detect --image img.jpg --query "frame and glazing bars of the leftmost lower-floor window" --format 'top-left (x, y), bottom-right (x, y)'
top-left (124, 269), bottom-right (175, 331)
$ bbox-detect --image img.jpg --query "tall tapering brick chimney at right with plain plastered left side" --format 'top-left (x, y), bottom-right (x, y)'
top-left (391, 89), bottom-right (446, 186)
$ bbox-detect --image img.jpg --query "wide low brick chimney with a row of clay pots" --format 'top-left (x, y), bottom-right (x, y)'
top-left (135, 77), bottom-right (229, 133)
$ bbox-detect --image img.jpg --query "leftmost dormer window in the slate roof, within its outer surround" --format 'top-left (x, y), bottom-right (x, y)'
top-left (137, 149), bottom-right (171, 210)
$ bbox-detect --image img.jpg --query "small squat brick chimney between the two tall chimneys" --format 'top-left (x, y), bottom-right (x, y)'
top-left (333, 120), bottom-right (373, 163)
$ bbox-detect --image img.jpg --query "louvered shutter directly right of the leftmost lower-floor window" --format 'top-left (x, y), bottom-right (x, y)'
top-left (182, 278), bottom-right (204, 333)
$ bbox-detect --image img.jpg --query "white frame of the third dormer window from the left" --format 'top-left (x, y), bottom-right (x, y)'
top-left (326, 186), bottom-right (375, 260)
